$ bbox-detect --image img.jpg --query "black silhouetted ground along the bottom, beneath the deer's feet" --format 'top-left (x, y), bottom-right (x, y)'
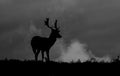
top-left (0, 60), bottom-right (120, 76)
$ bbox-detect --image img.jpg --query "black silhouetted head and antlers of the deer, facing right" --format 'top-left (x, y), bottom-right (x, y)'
top-left (45, 18), bottom-right (62, 38)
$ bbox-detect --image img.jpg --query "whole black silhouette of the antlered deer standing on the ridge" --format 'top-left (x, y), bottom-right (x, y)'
top-left (31, 18), bottom-right (62, 61)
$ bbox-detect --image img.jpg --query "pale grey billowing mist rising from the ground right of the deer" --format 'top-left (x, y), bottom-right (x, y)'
top-left (55, 39), bottom-right (112, 63)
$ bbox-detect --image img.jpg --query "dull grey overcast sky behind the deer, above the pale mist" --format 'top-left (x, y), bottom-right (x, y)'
top-left (0, 0), bottom-right (120, 59)
